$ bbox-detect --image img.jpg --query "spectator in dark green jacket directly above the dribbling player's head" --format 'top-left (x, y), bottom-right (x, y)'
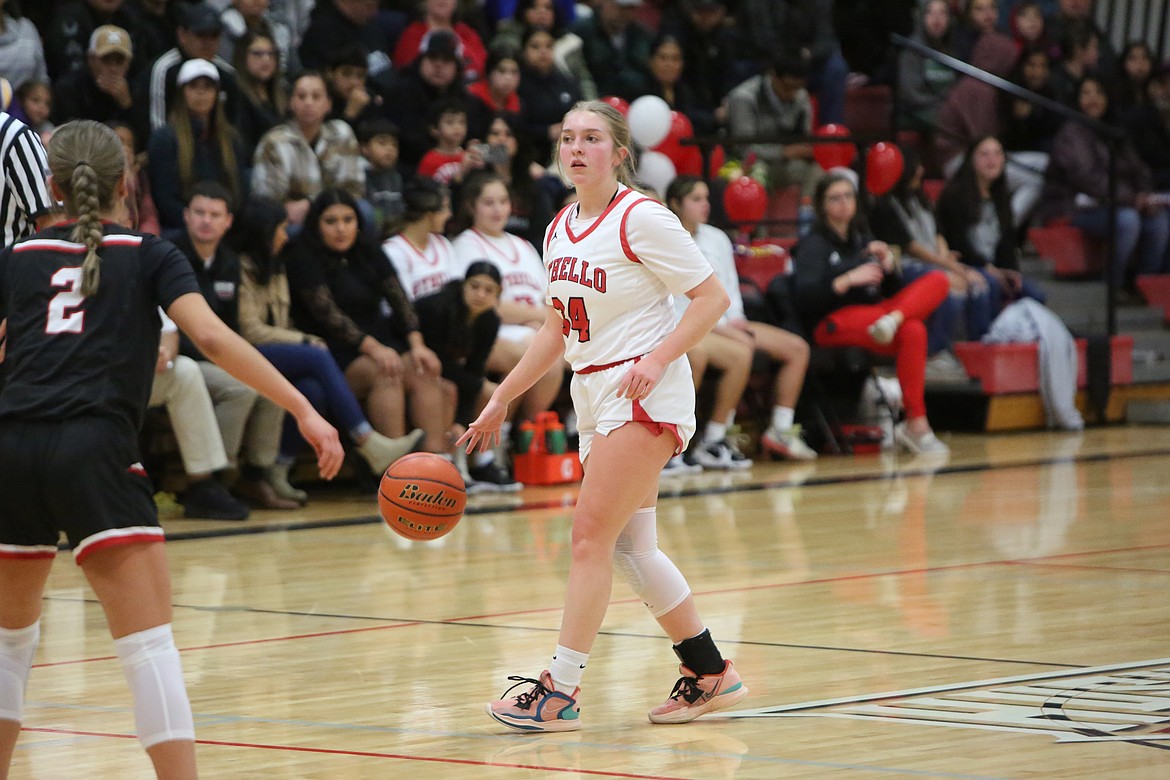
top-left (572, 0), bottom-right (653, 101)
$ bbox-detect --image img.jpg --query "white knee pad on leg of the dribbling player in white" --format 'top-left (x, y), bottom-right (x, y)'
top-left (613, 506), bottom-right (690, 617)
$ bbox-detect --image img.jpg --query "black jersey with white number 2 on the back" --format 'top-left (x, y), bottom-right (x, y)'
top-left (0, 225), bottom-right (199, 434)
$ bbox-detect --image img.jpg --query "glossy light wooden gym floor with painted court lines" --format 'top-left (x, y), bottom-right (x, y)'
top-left (13, 427), bottom-right (1170, 780)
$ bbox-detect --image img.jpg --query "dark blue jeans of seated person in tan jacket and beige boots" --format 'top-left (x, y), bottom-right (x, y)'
top-left (256, 344), bottom-right (370, 457)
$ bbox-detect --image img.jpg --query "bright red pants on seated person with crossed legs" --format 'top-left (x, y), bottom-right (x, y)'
top-left (813, 271), bottom-right (949, 420)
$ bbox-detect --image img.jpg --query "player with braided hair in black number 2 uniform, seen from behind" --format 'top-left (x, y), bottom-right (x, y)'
top-left (0, 120), bottom-right (343, 779)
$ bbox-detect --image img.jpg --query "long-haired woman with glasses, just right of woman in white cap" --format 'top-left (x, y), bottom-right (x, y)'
top-left (232, 33), bottom-right (289, 152)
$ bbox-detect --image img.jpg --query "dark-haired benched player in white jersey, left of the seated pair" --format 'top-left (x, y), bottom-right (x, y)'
top-left (381, 180), bottom-right (463, 301)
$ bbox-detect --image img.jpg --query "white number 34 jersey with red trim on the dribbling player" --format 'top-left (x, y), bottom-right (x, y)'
top-left (544, 186), bottom-right (711, 372)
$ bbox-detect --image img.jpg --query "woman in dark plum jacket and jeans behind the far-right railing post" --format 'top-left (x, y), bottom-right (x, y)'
top-left (1042, 76), bottom-right (1170, 292)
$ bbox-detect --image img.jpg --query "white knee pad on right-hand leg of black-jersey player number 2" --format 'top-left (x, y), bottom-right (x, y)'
top-left (113, 623), bottom-right (195, 748)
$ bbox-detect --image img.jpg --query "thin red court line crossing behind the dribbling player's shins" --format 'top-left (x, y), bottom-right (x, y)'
top-left (34, 545), bottom-right (1170, 669)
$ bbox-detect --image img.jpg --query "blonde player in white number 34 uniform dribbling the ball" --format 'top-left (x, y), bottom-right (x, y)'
top-left (460, 101), bottom-right (748, 732)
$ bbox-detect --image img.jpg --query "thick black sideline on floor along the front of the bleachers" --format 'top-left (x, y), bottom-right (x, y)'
top-left (143, 448), bottom-right (1170, 550)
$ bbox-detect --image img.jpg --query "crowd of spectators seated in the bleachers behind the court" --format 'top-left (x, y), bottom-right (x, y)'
top-left (0, 0), bottom-right (1170, 518)
